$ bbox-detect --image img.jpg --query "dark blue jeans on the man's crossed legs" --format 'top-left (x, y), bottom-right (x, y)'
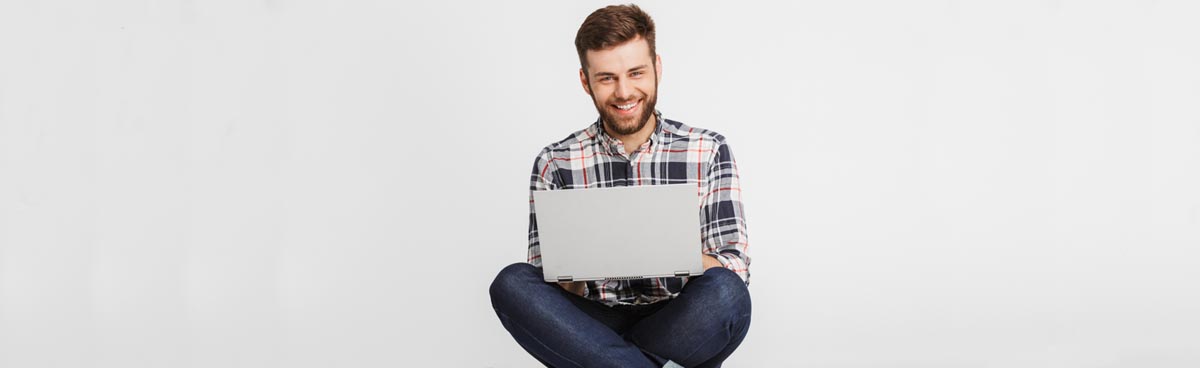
top-left (491, 263), bottom-right (750, 367)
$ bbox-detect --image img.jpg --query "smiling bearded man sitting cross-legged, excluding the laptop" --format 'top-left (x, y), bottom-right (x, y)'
top-left (491, 5), bottom-right (750, 367)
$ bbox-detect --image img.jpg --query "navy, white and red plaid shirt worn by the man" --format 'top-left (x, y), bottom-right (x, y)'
top-left (529, 111), bottom-right (750, 306)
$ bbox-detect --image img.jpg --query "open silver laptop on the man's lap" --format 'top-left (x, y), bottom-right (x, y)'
top-left (533, 183), bottom-right (703, 282)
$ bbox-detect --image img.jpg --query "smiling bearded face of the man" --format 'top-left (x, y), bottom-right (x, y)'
top-left (580, 37), bottom-right (662, 135)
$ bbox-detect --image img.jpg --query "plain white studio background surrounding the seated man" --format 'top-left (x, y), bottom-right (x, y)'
top-left (0, 0), bottom-right (1200, 368)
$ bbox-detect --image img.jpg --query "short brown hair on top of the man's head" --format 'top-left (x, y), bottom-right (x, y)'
top-left (575, 4), bottom-right (655, 71)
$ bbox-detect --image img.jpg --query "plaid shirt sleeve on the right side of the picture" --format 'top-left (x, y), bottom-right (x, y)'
top-left (700, 141), bottom-right (750, 285)
